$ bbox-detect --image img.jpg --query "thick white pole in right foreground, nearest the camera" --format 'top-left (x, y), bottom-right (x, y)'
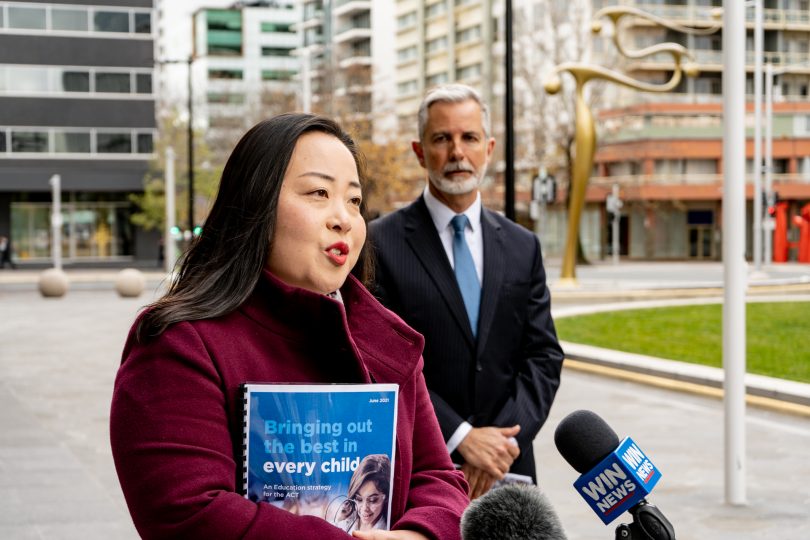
top-left (723, 0), bottom-right (746, 505)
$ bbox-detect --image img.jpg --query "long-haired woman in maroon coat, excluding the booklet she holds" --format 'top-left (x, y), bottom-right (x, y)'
top-left (110, 114), bottom-right (468, 540)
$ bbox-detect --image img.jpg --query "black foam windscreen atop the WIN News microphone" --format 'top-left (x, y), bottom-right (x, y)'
top-left (554, 410), bottom-right (619, 474)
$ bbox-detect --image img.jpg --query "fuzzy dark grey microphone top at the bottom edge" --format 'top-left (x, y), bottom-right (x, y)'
top-left (461, 483), bottom-right (566, 540)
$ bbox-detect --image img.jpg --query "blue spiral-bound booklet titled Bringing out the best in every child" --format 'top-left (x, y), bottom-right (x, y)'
top-left (243, 383), bottom-right (399, 533)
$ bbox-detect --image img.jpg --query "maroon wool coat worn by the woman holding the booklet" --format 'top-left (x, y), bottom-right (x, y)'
top-left (110, 272), bottom-right (469, 540)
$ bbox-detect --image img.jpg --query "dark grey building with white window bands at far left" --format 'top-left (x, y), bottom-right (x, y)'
top-left (0, 0), bottom-right (158, 264)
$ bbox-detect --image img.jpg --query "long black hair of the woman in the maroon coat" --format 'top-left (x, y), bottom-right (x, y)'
top-left (137, 113), bottom-right (373, 340)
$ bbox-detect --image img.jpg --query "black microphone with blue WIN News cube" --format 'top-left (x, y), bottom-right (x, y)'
top-left (554, 410), bottom-right (675, 540)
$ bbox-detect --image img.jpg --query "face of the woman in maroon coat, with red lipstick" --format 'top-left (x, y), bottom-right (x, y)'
top-left (267, 132), bottom-right (366, 294)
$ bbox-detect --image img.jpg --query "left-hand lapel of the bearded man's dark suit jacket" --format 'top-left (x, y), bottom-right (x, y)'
top-left (405, 197), bottom-right (476, 345)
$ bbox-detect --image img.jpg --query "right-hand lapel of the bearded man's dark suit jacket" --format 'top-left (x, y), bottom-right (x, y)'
top-left (478, 208), bottom-right (506, 354)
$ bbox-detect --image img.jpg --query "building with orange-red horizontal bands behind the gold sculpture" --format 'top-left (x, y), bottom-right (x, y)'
top-left (583, 0), bottom-right (810, 260)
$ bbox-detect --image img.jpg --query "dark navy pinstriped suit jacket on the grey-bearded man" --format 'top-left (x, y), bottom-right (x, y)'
top-left (369, 197), bottom-right (563, 478)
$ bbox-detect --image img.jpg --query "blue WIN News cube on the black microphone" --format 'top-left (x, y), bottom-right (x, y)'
top-left (574, 437), bottom-right (661, 525)
